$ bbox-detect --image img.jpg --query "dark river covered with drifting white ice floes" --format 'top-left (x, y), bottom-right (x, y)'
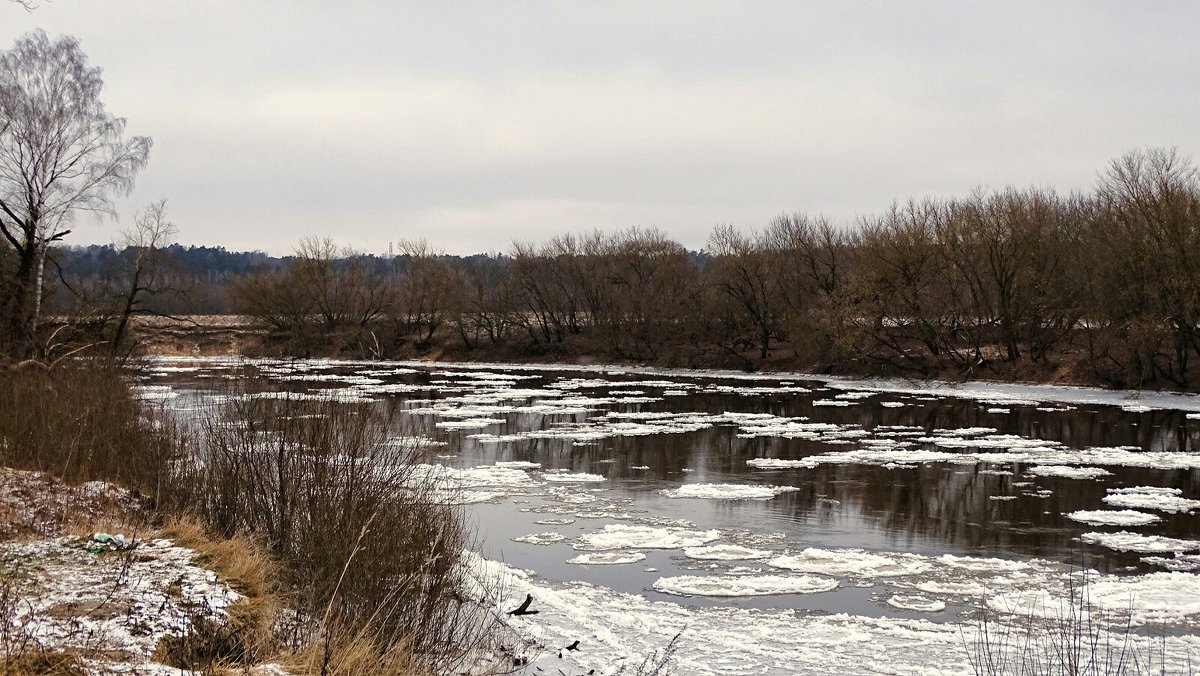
top-left (142, 359), bottom-right (1200, 674)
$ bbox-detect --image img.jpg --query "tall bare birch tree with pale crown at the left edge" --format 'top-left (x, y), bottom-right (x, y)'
top-left (0, 30), bottom-right (151, 354)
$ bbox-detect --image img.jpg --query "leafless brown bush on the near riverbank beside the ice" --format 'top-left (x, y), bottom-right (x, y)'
top-left (174, 397), bottom-right (496, 671)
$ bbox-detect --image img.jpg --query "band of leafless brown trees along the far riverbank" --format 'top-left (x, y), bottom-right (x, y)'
top-left (39, 149), bottom-right (1200, 389)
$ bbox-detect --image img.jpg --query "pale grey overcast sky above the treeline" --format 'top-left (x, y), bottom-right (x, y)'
top-left (0, 0), bottom-right (1200, 255)
